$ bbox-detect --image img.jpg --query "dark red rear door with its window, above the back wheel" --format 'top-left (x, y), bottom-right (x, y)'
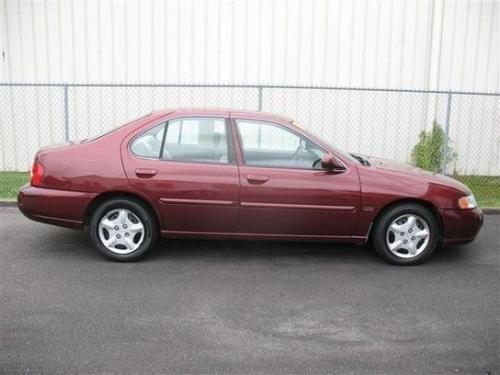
top-left (123, 116), bottom-right (239, 233)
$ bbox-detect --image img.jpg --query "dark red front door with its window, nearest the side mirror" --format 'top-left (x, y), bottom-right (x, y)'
top-left (236, 119), bottom-right (360, 238)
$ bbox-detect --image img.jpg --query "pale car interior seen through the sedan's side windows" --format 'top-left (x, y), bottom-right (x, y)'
top-left (131, 119), bottom-right (324, 169)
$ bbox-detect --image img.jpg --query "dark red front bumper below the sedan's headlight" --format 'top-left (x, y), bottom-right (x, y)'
top-left (439, 208), bottom-right (484, 246)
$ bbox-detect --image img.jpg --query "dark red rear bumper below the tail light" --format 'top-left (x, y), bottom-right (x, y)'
top-left (17, 184), bottom-right (97, 229)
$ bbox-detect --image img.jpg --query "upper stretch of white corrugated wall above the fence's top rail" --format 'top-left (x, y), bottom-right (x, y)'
top-left (2, 0), bottom-right (499, 91)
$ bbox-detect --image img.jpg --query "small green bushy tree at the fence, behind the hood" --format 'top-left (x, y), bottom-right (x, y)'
top-left (411, 120), bottom-right (457, 172)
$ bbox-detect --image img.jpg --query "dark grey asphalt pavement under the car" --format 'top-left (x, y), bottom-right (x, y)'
top-left (0, 208), bottom-right (500, 374)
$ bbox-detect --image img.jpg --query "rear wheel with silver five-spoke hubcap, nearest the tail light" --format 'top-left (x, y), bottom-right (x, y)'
top-left (89, 198), bottom-right (158, 262)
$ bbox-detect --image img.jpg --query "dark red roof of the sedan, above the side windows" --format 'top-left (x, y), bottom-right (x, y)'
top-left (152, 108), bottom-right (292, 123)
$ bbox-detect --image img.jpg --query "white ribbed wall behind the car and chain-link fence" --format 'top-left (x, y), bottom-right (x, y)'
top-left (0, 0), bottom-right (500, 175)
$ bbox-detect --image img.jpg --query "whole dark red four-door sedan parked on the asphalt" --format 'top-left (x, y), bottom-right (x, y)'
top-left (18, 110), bottom-right (483, 264)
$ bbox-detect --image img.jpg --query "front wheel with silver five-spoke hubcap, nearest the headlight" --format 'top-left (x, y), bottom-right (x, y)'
top-left (373, 203), bottom-right (441, 266)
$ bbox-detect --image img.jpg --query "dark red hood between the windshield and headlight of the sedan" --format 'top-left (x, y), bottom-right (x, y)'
top-left (366, 157), bottom-right (471, 194)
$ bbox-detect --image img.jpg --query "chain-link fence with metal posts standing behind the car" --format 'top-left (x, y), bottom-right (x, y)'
top-left (0, 83), bottom-right (500, 206)
